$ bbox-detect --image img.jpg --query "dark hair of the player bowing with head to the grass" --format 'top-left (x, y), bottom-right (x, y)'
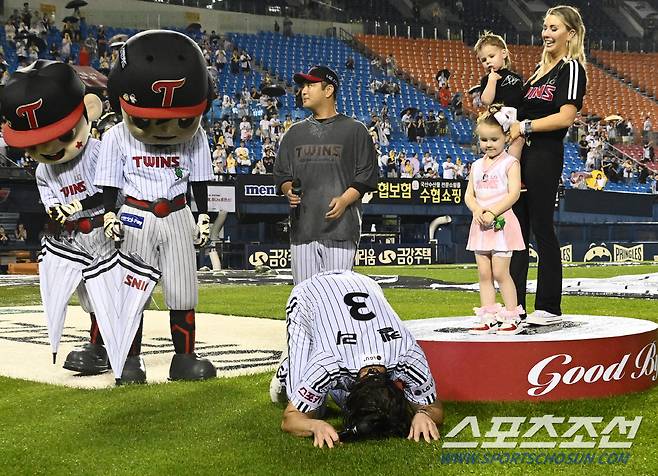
top-left (344, 373), bottom-right (413, 438)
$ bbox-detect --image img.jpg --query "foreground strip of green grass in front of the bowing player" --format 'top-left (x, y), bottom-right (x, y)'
top-left (0, 374), bottom-right (658, 475)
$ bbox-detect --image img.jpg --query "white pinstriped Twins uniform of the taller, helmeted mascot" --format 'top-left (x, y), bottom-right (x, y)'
top-left (95, 122), bottom-right (213, 309)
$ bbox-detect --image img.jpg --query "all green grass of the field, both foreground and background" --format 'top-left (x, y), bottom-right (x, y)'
top-left (0, 266), bottom-right (658, 476)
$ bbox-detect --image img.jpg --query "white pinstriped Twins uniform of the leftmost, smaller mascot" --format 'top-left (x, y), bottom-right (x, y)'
top-left (36, 137), bottom-right (112, 312)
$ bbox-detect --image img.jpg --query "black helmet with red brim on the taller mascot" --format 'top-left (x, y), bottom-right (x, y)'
top-left (107, 30), bottom-right (212, 119)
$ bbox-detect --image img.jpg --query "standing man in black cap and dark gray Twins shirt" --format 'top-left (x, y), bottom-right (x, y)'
top-left (274, 66), bottom-right (379, 284)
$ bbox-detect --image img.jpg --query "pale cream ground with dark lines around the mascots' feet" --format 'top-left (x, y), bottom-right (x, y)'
top-left (0, 306), bottom-right (285, 388)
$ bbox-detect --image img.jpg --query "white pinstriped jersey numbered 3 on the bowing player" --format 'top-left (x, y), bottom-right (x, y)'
top-left (277, 271), bottom-right (436, 412)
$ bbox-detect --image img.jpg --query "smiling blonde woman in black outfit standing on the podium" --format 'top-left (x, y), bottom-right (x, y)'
top-left (510, 5), bottom-right (587, 324)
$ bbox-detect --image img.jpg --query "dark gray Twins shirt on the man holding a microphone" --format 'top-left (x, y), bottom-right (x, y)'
top-left (274, 114), bottom-right (379, 244)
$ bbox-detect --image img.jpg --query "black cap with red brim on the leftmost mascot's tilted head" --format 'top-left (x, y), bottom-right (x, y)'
top-left (0, 59), bottom-right (85, 148)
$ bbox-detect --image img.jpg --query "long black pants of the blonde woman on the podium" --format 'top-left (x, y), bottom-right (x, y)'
top-left (510, 140), bottom-right (564, 315)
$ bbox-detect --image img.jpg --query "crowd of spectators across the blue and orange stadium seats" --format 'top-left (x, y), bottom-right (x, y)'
top-left (0, 3), bottom-right (658, 195)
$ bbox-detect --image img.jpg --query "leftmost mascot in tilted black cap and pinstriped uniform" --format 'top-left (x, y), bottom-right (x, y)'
top-left (1, 60), bottom-right (119, 375)
